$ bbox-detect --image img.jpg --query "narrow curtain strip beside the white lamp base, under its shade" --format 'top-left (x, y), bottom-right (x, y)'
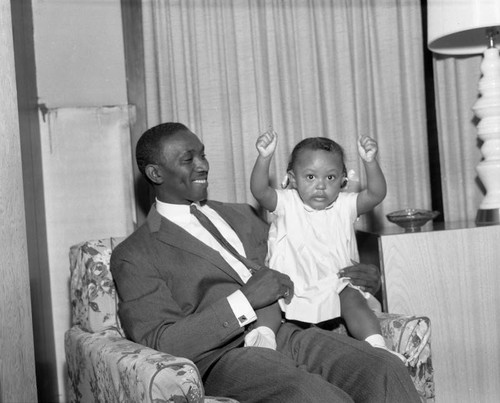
top-left (434, 55), bottom-right (483, 221)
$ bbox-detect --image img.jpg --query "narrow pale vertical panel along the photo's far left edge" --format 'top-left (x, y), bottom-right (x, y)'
top-left (0, 0), bottom-right (36, 402)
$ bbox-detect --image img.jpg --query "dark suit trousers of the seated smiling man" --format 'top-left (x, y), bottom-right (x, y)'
top-left (204, 323), bottom-right (420, 403)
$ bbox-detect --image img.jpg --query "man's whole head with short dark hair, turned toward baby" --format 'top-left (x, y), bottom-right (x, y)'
top-left (136, 123), bottom-right (209, 204)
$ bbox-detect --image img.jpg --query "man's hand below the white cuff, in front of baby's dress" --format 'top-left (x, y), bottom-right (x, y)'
top-left (241, 267), bottom-right (293, 309)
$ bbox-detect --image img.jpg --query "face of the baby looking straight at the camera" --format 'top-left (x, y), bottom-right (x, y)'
top-left (290, 149), bottom-right (344, 210)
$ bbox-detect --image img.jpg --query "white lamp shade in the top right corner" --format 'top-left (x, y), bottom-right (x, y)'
top-left (427, 0), bottom-right (500, 55)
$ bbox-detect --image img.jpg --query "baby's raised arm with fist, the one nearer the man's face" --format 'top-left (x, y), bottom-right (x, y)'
top-left (250, 130), bottom-right (278, 211)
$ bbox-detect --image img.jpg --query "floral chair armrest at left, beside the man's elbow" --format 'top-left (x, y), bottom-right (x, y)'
top-left (65, 326), bottom-right (235, 403)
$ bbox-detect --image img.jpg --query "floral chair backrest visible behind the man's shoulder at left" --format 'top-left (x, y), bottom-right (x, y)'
top-left (69, 237), bottom-right (125, 335)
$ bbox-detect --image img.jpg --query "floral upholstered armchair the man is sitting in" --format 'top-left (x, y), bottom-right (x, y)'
top-left (65, 238), bottom-right (434, 403)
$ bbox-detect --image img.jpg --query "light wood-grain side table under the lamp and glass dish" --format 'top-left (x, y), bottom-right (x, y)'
top-left (357, 223), bottom-right (500, 403)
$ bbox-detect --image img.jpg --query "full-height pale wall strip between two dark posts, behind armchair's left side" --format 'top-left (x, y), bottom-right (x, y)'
top-left (32, 0), bottom-right (135, 401)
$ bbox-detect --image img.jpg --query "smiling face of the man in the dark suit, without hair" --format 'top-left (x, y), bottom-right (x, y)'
top-left (152, 130), bottom-right (209, 204)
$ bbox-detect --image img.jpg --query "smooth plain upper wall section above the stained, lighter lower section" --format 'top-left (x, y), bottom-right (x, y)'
top-left (33, 0), bottom-right (127, 108)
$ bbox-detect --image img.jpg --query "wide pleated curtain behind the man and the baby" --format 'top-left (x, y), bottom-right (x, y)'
top-left (143, 0), bottom-right (431, 227)
